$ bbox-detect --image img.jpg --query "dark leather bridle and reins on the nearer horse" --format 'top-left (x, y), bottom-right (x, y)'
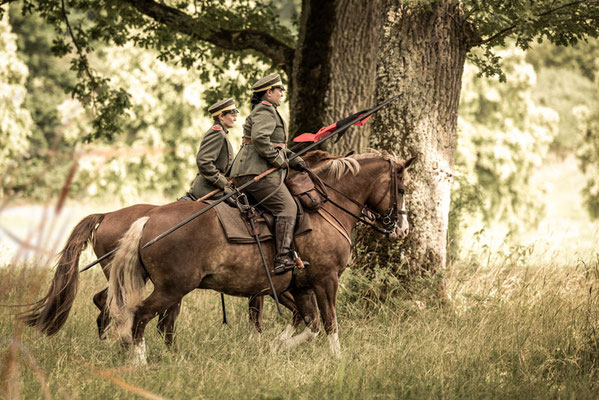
top-left (322, 160), bottom-right (407, 235)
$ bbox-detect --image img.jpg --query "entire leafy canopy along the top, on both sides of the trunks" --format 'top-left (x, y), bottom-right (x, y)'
top-left (0, 0), bottom-right (599, 140)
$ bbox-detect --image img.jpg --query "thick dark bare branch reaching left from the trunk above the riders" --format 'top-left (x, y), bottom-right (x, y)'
top-left (125, 0), bottom-right (295, 72)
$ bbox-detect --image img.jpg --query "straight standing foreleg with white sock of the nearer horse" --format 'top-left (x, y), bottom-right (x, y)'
top-left (314, 275), bottom-right (341, 357)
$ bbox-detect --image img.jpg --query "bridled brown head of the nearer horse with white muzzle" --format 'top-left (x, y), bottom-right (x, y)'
top-left (356, 152), bottom-right (416, 239)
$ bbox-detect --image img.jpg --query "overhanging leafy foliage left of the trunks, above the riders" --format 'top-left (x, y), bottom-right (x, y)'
top-left (0, 0), bottom-right (295, 141)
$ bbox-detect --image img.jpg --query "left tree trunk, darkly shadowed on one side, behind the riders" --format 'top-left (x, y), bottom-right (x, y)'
top-left (290, 0), bottom-right (381, 154)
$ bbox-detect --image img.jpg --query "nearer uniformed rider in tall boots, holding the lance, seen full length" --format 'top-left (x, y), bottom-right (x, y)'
top-left (231, 74), bottom-right (306, 274)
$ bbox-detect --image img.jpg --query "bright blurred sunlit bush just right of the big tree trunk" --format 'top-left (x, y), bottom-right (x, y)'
top-left (449, 48), bottom-right (558, 244)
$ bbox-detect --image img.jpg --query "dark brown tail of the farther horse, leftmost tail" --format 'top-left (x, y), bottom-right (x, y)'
top-left (19, 214), bottom-right (104, 335)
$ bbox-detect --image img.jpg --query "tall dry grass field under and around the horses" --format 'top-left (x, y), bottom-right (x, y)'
top-left (0, 158), bottom-right (599, 399)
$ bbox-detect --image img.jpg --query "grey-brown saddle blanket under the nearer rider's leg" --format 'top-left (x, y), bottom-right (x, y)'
top-left (207, 202), bottom-right (312, 244)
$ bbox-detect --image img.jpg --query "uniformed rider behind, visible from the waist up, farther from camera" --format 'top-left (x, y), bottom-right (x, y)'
top-left (188, 98), bottom-right (239, 200)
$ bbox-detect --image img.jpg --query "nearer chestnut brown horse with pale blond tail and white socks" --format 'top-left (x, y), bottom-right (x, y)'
top-left (102, 152), bottom-right (413, 363)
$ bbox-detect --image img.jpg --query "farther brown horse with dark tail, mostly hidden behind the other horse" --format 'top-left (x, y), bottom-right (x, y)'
top-left (24, 204), bottom-right (302, 346)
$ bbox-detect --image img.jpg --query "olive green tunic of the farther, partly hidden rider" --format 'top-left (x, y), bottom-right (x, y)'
top-left (190, 124), bottom-right (233, 198)
